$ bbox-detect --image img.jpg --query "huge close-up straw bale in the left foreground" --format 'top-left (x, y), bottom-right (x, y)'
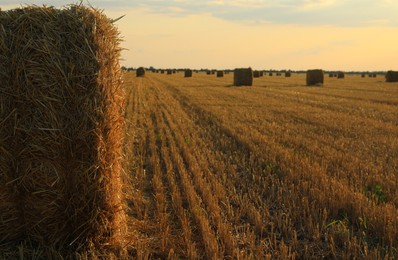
top-left (0, 5), bottom-right (127, 258)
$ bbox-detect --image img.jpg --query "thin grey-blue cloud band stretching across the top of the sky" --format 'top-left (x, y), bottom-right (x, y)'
top-left (1, 0), bottom-right (398, 27)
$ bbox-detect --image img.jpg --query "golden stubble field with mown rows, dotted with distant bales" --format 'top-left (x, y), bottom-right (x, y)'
top-left (124, 72), bottom-right (398, 259)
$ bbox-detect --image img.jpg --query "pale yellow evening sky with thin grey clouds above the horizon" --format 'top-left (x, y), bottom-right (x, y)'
top-left (0, 0), bottom-right (398, 71)
